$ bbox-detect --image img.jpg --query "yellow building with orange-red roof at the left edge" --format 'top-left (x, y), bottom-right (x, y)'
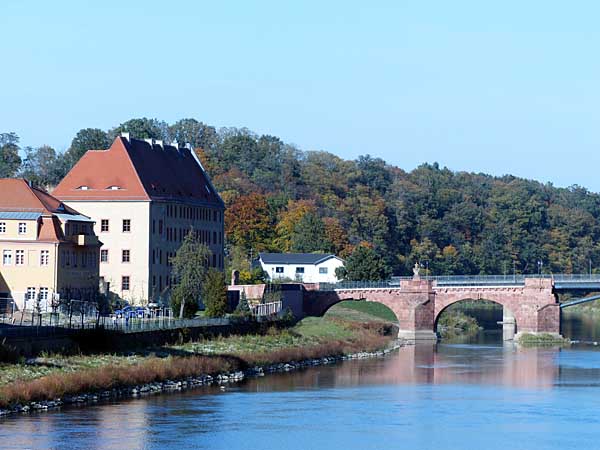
top-left (0, 179), bottom-right (101, 309)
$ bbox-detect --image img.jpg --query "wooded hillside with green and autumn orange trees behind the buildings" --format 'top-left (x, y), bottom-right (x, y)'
top-left (0, 119), bottom-right (600, 275)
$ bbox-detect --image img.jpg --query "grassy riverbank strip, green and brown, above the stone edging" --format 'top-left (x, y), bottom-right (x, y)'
top-left (0, 307), bottom-right (393, 407)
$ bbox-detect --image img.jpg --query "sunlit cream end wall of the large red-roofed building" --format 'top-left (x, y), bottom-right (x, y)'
top-left (64, 201), bottom-right (150, 303)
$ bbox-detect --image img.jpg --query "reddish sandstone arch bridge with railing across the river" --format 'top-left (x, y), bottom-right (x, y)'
top-left (304, 275), bottom-right (600, 340)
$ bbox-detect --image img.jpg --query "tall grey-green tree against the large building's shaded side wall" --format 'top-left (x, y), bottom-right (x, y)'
top-left (170, 231), bottom-right (212, 318)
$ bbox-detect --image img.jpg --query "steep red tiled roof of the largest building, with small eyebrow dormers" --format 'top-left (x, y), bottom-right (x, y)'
top-left (53, 137), bottom-right (223, 206)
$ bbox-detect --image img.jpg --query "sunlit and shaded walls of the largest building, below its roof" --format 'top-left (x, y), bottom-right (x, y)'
top-left (64, 201), bottom-right (224, 304)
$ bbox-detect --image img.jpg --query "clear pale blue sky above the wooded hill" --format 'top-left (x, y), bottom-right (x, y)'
top-left (0, 0), bottom-right (600, 191)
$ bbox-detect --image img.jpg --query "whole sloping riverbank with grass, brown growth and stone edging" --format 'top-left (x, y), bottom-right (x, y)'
top-left (0, 306), bottom-right (400, 416)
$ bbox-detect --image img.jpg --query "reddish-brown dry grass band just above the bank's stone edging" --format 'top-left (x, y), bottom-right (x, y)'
top-left (0, 318), bottom-right (389, 407)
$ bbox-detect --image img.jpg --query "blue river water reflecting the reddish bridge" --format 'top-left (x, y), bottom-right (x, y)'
top-left (0, 314), bottom-right (600, 450)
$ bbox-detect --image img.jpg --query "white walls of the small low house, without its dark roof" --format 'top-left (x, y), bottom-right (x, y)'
top-left (260, 255), bottom-right (344, 283)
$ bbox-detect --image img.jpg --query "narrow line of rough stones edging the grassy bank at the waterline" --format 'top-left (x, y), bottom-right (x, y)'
top-left (0, 341), bottom-right (404, 417)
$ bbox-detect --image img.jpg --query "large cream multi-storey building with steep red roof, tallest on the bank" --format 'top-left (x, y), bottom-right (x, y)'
top-left (53, 133), bottom-right (225, 304)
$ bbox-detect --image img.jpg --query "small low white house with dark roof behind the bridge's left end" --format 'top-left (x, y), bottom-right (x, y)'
top-left (259, 253), bottom-right (344, 283)
